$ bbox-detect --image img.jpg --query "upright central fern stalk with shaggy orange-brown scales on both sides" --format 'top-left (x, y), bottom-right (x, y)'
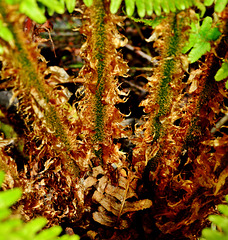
top-left (80, 0), bottom-right (127, 164)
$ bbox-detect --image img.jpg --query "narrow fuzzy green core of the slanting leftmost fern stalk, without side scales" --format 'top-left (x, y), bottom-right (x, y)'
top-left (0, 2), bottom-right (79, 176)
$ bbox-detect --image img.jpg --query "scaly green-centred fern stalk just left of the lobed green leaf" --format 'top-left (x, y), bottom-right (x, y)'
top-left (134, 14), bottom-right (183, 175)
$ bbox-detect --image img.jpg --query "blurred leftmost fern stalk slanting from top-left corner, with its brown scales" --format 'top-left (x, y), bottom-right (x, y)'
top-left (0, 1), bottom-right (79, 176)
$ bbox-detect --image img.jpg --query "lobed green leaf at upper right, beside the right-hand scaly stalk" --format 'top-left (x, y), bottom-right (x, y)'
top-left (183, 17), bottom-right (221, 63)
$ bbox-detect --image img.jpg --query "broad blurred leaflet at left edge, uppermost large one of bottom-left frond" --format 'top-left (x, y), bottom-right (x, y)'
top-left (0, 188), bottom-right (22, 209)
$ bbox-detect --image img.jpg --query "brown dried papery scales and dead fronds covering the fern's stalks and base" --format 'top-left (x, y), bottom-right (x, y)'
top-left (0, 0), bottom-right (228, 239)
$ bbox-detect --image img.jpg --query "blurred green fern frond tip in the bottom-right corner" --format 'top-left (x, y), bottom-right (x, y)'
top-left (201, 195), bottom-right (228, 240)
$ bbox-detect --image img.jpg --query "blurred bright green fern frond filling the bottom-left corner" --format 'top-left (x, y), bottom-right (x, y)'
top-left (0, 171), bottom-right (79, 240)
